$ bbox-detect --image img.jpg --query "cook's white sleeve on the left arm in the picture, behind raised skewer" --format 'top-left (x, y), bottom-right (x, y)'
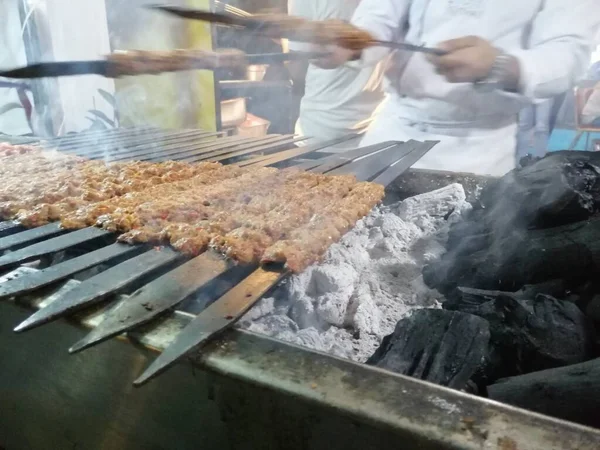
top-left (352, 0), bottom-right (411, 65)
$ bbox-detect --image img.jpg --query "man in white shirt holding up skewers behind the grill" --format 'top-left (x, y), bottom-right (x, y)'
top-left (320, 0), bottom-right (600, 175)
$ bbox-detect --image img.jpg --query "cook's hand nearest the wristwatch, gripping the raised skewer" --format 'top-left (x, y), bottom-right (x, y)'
top-left (429, 36), bottom-right (500, 83)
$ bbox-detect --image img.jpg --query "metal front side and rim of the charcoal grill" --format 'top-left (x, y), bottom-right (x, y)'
top-left (0, 292), bottom-right (600, 450)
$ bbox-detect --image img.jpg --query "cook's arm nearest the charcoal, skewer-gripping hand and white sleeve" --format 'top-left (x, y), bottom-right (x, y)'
top-left (431, 0), bottom-right (600, 101)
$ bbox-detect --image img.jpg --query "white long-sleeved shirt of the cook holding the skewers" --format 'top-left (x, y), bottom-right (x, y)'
top-left (352, 0), bottom-right (600, 130)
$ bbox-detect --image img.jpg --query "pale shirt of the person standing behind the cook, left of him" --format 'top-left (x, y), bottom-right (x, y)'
top-left (288, 0), bottom-right (384, 140)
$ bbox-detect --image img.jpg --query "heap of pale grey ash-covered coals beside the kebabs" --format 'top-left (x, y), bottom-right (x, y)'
top-left (238, 184), bottom-right (471, 362)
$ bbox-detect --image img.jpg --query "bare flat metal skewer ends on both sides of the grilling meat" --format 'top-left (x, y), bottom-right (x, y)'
top-left (0, 128), bottom-right (436, 384)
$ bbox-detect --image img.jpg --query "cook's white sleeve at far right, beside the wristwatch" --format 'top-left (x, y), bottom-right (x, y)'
top-left (510, 0), bottom-right (600, 100)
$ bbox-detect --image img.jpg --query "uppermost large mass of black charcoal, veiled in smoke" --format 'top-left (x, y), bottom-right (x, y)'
top-left (423, 152), bottom-right (600, 296)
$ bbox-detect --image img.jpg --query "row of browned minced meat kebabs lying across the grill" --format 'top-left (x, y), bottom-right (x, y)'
top-left (0, 142), bottom-right (384, 272)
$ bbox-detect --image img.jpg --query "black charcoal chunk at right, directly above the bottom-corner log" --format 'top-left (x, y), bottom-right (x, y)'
top-left (469, 294), bottom-right (594, 379)
